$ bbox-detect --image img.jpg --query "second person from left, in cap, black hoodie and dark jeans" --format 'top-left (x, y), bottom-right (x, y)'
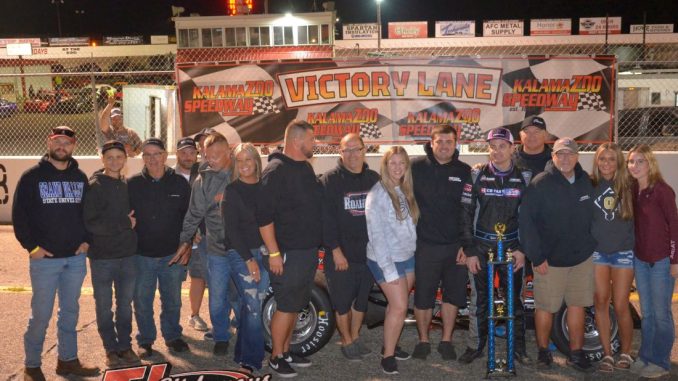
top-left (84, 140), bottom-right (139, 368)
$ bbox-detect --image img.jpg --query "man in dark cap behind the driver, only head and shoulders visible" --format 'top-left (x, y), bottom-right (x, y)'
top-left (513, 115), bottom-right (551, 176)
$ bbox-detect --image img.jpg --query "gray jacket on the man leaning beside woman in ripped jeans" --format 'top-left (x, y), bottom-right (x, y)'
top-left (179, 167), bottom-right (231, 256)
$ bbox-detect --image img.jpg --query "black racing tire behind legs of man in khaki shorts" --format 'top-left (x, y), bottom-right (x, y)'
top-left (551, 305), bottom-right (621, 361)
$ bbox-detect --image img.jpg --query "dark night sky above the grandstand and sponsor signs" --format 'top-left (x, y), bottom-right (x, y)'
top-left (0, 0), bottom-right (678, 38)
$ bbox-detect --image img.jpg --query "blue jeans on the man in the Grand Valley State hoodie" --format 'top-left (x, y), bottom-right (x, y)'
top-left (24, 255), bottom-right (87, 368)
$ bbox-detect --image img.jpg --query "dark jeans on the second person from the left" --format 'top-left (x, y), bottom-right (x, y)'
top-left (89, 256), bottom-right (137, 353)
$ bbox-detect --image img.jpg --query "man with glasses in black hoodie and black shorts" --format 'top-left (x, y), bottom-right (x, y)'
top-left (320, 134), bottom-right (379, 360)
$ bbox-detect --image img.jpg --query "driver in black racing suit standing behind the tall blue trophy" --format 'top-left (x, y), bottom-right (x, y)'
top-left (459, 127), bottom-right (532, 365)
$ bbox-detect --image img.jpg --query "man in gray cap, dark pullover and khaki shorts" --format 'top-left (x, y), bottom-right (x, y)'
top-left (519, 138), bottom-right (596, 373)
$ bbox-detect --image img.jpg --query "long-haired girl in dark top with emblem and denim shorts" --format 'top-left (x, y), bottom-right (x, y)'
top-left (591, 143), bottom-right (634, 372)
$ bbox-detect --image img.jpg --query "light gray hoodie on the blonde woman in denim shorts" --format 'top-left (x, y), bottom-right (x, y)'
top-left (365, 182), bottom-right (417, 282)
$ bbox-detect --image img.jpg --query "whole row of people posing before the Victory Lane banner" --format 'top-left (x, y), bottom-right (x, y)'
top-left (12, 114), bottom-right (678, 380)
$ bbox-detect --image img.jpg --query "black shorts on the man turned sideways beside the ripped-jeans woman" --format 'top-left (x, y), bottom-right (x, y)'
top-left (264, 248), bottom-right (318, 313)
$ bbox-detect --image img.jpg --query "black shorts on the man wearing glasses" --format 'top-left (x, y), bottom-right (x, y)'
top-left (325, 254), bottom-right (374, 315)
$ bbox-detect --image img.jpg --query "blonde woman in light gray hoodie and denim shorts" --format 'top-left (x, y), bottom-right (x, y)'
top-left (365, 146), bottom-right (419, 374)
